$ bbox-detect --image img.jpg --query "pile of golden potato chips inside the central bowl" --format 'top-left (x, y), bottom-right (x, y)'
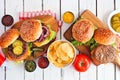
top-left (47, 40), bottom-right (75, 68)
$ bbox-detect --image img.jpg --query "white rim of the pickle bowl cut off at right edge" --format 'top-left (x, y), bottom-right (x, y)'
top-left (107, 10), bottom-right (120, 35)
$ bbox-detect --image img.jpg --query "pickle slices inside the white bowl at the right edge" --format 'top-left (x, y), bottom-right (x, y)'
top-left (111, 13), bottom-right (120, 33)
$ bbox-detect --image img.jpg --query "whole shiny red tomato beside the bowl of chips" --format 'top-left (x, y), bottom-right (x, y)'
top-left (73, 54), bottom-right (91, 72)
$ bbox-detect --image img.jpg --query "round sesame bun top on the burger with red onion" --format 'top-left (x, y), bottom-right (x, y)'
top-left (20, 19), bottom-right (42, 42)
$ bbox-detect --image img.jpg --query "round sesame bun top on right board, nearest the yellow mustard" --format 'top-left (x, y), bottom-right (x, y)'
top-left (72, 19), bottom-right (94, 43)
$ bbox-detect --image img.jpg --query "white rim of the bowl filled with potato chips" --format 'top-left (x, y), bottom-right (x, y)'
top-left (47, 40), bottom-right (76, 68)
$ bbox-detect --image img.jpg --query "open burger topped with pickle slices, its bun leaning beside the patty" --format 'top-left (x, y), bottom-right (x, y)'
top-left (0, 29), bottom-right (29, 61)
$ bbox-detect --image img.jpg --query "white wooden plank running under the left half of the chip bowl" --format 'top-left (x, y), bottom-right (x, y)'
top-left (43, 0), bottom-right (61, 80)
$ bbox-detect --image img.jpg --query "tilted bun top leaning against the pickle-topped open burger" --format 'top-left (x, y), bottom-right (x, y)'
top-left (0, 29), bottom-right (19, 48)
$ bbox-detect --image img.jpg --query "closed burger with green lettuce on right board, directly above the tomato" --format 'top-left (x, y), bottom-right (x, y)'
top-left (70, 18), bottom-right (97, 53)
